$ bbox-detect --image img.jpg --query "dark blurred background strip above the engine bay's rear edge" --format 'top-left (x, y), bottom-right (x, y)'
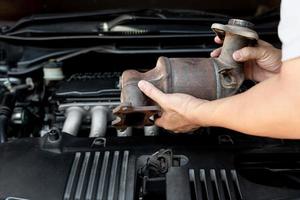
top-left (0, 0), bottom-right (280, 21)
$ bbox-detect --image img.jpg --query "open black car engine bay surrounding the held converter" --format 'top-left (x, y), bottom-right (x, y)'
top-left (0, 7), bottom-right (300, 200)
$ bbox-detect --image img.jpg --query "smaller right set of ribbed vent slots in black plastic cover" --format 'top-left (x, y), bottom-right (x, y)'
top-left (189, 169), bottom-right (243, 200)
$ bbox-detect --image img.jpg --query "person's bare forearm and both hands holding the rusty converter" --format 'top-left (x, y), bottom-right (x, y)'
top-left (138, 38), bottom-right (300, 139)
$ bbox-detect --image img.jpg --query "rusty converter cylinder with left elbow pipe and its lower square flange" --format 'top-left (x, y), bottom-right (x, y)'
top-left (112, 57), bottom-right (217, 129)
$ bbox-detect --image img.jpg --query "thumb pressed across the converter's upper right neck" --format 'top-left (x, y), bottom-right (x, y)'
top-left (232, 47), bottom-right (266, 62)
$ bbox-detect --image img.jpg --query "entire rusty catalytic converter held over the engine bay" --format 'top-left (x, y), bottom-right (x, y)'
top-left (112, 19), bottom-right (258, 129)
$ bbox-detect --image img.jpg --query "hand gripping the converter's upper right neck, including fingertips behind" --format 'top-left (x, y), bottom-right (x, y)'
top-left (210, 36), bottom-right (282, 82)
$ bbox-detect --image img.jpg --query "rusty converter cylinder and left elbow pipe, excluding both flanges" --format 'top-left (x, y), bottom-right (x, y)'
top-left (121, 57), bottom-right (216, 101)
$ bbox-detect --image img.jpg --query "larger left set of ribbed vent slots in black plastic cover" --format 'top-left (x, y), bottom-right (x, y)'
top-left (64, 151), bottom-right (133, 200)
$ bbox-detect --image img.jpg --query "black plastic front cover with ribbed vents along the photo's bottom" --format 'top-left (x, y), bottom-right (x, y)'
top-left (0, 134), bottom-right (300, 200)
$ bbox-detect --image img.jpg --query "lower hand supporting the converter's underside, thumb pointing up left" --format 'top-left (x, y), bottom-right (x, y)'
top-left (138, 80), bottom-right (207, 133)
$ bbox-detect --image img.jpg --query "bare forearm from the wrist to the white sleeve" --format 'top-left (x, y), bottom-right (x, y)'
top-left (196, 58), bottom-right (300, 138)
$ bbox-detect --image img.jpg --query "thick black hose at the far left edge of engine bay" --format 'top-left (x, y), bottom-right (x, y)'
top-left (0, 92), bottom-right (15, 143)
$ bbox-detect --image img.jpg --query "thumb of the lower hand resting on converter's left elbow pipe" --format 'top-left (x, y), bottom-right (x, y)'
top-left (138, 80), bottom-right (166, 105)
